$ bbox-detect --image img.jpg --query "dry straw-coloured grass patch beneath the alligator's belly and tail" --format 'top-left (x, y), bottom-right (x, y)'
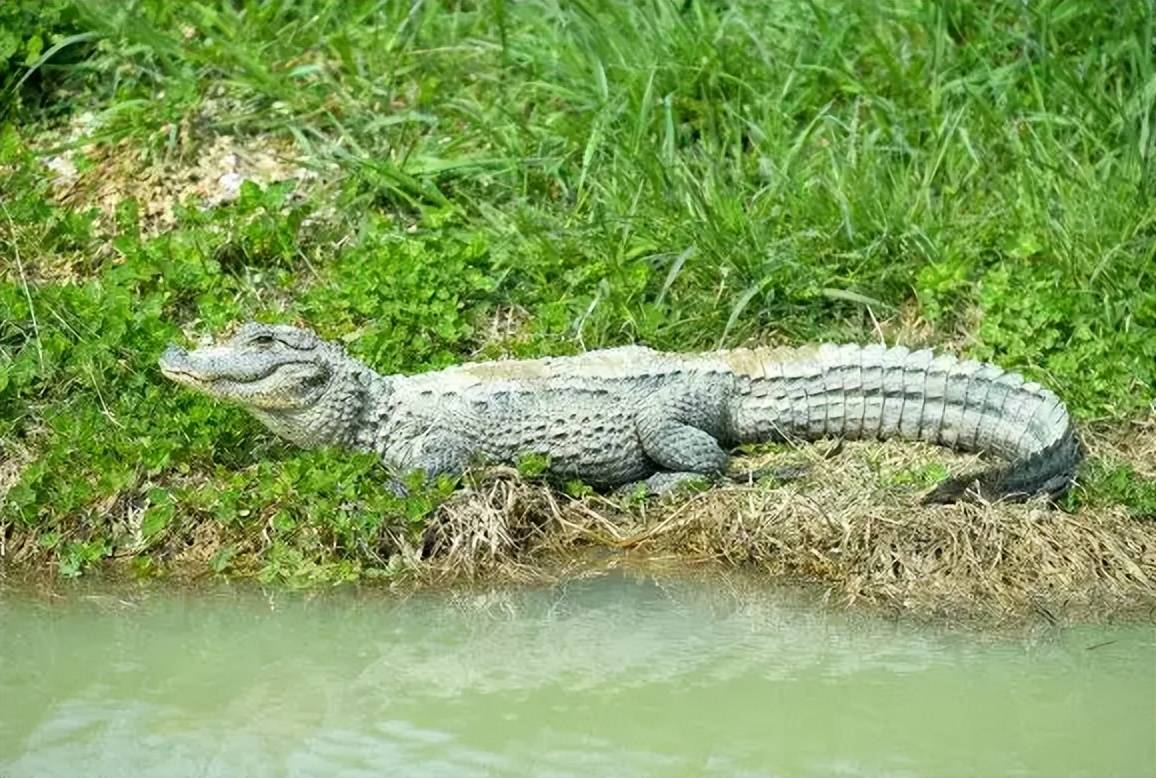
top-left (412, 443), bottom-right (1156, 620)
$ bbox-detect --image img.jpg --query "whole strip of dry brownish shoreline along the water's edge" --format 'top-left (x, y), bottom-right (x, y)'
top-left (3, 443), bottom-right (1156, 624)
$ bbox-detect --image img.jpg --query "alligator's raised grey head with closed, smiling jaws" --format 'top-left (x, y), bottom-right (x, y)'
top-left (160, 324), bottom-right (369, 446)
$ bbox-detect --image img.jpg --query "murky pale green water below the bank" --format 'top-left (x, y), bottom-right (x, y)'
top-left (0, 575), bottom-right (1156, 778)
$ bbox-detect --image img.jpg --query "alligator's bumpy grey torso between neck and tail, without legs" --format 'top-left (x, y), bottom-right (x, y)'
top-left (392, 346), bottom-right (712, 487)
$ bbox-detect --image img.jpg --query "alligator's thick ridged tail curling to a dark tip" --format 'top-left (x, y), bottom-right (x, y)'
top-left (719, 344), bottom-right (1081, 502)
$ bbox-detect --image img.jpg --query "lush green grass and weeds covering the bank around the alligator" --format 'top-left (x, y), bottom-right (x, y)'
top-left (0, 0), bottom-right (1156, 578)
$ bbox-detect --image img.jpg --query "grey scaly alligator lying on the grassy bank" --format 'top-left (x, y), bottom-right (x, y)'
top-left (160, 323), bottom-right (1081, 502)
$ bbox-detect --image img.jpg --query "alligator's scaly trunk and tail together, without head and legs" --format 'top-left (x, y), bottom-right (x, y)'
top-left (388, 344), bottom-right (1080, 499)
